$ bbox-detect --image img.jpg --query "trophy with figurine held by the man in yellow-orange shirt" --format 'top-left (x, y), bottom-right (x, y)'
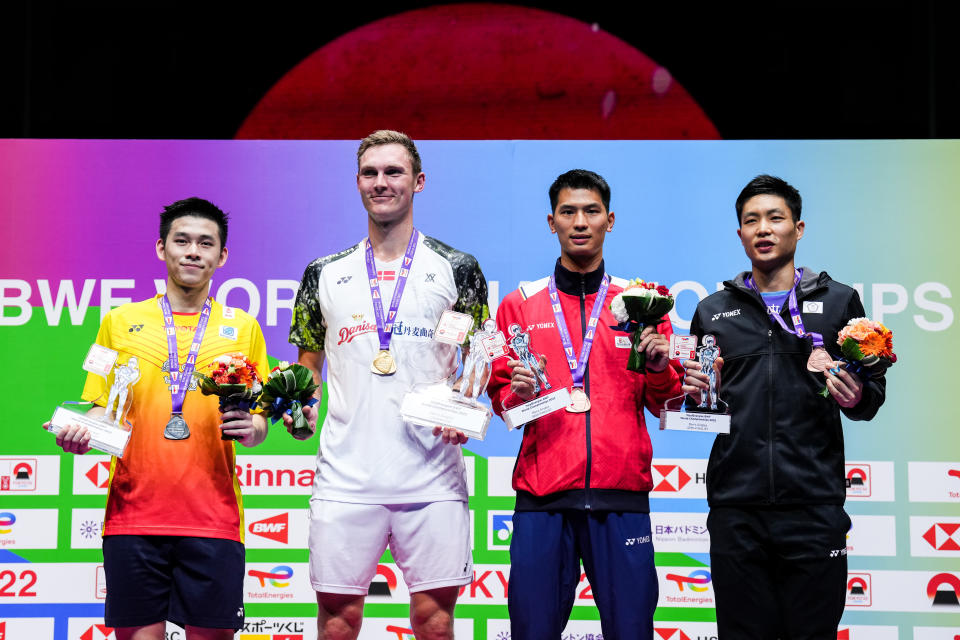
top-left (47, 344), bottom-right (140, 458)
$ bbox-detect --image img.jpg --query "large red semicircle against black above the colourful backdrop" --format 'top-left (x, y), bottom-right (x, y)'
top-left (237, 3), bottom-right (719, 140)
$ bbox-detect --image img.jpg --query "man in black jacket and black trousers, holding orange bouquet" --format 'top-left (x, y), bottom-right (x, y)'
top-left (684, 175), bottom-right (885, 640)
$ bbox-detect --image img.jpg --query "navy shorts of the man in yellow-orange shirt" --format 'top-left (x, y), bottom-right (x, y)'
top-left (103, 536), bottom-right (244, 631)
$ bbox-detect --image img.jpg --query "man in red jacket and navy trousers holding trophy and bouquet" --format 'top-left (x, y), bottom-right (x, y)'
top-left (488, 169), bottom-right (681, 640)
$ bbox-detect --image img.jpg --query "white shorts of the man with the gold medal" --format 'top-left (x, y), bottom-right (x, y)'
top-left (310, 499), bottom-right (473, 595)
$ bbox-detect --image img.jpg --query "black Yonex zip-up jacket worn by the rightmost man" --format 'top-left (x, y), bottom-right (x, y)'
top-left (690, 268), bottom-right (886, 506)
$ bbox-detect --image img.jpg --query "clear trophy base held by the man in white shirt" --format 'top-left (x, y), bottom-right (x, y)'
top-left (400, 382), bottom-right (492, 440)
